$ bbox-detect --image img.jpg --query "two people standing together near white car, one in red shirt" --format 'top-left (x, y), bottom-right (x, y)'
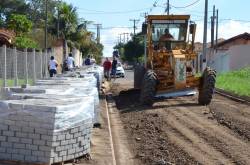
top-left (103, 56), bottom-right (117, 80)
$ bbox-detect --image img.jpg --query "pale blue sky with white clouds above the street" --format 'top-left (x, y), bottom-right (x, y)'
top-left (64, 0), bottom-right (250, 56)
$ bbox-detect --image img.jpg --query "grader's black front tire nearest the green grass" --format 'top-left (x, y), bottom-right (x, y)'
top-left (198, 67), bottom-right (216, 105)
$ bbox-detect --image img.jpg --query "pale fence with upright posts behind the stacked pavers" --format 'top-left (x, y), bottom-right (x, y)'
top-left (0, 46), bottom-right (53, 87)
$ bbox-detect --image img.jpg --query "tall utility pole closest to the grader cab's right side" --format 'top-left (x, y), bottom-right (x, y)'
top-left (202, 0), bottom-right (208, 71)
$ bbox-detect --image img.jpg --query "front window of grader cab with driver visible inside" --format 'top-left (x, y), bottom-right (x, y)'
top-left (151, 20), bottom-right (187, 49)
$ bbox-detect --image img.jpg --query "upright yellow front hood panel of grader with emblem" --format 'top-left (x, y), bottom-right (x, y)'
top-left (172, 50), bottom-right (186, 89)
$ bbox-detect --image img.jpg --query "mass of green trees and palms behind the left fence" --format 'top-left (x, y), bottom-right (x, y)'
top-left (0, 0), bottom-right (103, 61)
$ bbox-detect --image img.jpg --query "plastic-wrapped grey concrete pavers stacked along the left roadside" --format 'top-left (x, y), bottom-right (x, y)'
top-left (0, 66), bottom-right (102, 164)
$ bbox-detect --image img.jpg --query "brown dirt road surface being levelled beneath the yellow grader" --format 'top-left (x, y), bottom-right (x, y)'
top-left (111, 72), bottom-right (250, 165)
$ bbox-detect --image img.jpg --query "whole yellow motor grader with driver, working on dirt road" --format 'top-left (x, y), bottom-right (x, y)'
top-left (135, 15), bottom-right (216, 105)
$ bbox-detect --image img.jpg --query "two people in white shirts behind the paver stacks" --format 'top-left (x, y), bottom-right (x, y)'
top-left (48, 53), bottom-right (75, 77)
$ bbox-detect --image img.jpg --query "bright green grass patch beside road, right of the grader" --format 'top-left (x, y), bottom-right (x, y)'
top-left (216, 67), bottom-right (250, 97)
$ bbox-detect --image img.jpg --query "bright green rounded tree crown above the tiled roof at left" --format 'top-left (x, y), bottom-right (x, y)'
top-left (7, 14), bottom-right (32, 36)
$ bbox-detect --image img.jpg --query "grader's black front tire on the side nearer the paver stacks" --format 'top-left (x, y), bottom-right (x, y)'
top-left (140, 70), bottom-right (157, 106)
